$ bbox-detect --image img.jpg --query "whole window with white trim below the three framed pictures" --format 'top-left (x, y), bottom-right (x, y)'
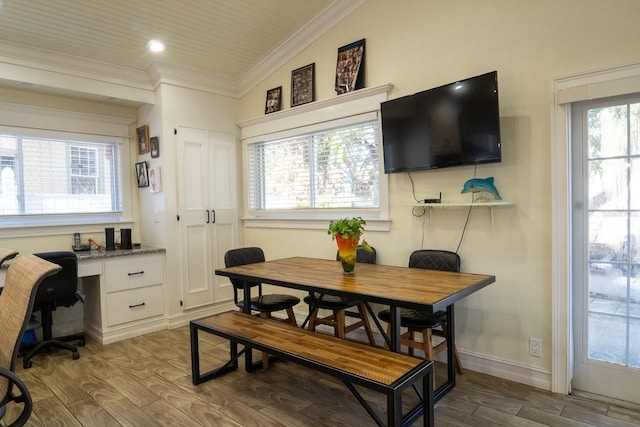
top-left (238, 85), bottom-right (391, 231)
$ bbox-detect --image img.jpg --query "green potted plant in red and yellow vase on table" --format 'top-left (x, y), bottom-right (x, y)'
top-left (327, 217), bottom-right (371, 274)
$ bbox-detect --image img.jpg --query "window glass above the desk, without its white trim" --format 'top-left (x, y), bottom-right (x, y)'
top-left (0, 131), bottom-right (122, 217)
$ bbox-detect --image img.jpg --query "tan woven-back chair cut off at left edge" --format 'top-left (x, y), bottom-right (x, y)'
top-left (0, 249), bottom-right (60, 426)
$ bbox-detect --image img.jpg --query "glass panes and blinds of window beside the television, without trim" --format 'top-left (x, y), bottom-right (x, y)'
top-left (247, 120), bottom-right (380, 214)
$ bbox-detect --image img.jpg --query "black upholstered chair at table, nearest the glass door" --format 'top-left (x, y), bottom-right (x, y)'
top-left (378, 249), bottom-right (462, 374)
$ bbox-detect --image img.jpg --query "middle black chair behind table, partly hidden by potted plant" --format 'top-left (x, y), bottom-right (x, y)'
top-left (304, 246), bottom-right (377, 345)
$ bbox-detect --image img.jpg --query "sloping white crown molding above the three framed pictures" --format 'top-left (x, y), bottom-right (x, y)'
top-left (238, 0), bottom-right (368, 97)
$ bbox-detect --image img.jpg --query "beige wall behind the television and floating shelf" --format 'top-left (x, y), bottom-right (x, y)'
top-left (241, 0), bottom-right (640, 372)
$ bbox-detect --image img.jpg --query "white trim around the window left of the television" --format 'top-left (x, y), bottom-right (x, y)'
top-left (238, 84), bottom-right (391, 231)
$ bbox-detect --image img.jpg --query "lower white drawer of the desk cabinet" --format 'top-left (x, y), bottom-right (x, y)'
top-left (106, 285), bottom-right (164, 326)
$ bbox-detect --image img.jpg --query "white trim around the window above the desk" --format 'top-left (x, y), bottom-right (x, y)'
top-left (0, 102), bottom-right (134, 238)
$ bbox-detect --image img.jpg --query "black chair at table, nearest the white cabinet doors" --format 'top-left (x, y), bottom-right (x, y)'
top-left (224, 247), bottom-right (300, 368)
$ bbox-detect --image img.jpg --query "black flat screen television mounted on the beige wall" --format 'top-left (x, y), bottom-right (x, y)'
top-left (380, 71), bottom-right (502, 173)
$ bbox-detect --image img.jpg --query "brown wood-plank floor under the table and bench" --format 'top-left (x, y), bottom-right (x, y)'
top-left (5, 327), bottom-right (640, 427)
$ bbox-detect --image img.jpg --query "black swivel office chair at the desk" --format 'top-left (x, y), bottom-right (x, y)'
top-left (22, 251), bottom-right (85, 369)
